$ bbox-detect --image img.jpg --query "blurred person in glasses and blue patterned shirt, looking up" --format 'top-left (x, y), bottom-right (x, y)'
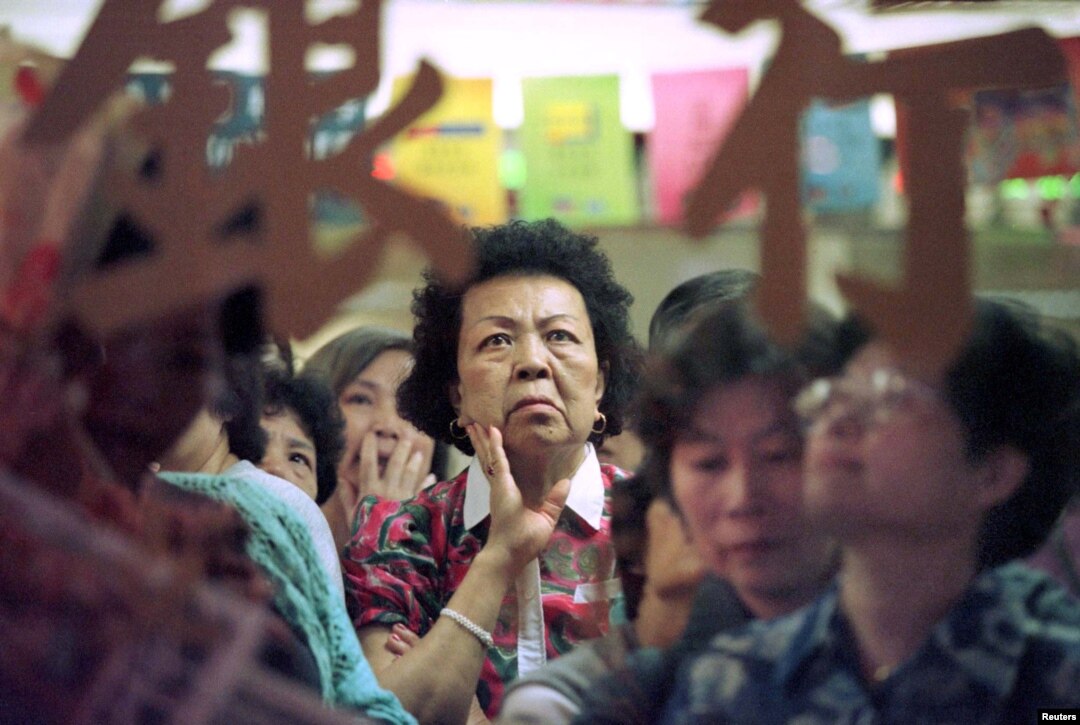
top-left (665, 301), bottom-right (1080, 723)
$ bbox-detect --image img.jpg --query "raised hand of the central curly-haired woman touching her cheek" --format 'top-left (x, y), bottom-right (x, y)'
top-left (465, 422), bottom-right (570, 568)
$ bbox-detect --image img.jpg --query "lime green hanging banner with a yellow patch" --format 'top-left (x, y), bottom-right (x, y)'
top-left (519, 76), bottom-right (640, 226)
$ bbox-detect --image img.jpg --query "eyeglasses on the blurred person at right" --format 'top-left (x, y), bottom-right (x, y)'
top-left (792, 368), bottom-right (941, 426)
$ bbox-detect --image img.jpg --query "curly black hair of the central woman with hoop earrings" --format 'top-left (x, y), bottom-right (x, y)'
top-left (397, 219), bottom-right (642, 455)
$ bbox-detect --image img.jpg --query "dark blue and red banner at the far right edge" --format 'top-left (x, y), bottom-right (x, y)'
top-left (968, 83), bottom-right (1080, 184)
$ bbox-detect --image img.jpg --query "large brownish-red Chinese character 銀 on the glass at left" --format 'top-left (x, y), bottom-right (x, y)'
top-left (24, 0), bottom-right (470, 336)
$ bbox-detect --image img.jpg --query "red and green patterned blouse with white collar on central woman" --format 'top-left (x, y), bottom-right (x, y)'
top-left (342, 448), bottom-right (627, 717)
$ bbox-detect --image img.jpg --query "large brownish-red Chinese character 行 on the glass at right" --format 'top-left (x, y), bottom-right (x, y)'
top-left (686, 0), bottom-right (1066, 380)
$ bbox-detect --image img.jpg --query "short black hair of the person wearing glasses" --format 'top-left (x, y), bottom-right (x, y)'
top-left (943, 298), bottom-right (1080, 566)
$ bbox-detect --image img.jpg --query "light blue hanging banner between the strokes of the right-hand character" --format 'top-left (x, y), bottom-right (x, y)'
top-left (802, 99), bottom-right (881, 212)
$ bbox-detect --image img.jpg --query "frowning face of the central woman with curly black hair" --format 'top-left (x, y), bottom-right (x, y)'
top-left (450, 276), bottom-right (604, 462)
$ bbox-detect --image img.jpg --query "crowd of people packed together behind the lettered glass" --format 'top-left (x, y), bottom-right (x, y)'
top-left (0, 88), bottom-right (1080, 723)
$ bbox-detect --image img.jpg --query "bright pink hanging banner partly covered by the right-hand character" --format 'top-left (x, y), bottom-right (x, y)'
top-left (648, 68), bottom-right (756, 224)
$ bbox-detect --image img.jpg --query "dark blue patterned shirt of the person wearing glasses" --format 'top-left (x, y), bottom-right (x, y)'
top-left (662, 563), bottom-right (1080, 725)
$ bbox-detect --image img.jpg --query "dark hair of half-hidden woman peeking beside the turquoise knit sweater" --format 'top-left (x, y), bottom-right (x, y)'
top-left (262, 370), bottom-right (345, 505)
